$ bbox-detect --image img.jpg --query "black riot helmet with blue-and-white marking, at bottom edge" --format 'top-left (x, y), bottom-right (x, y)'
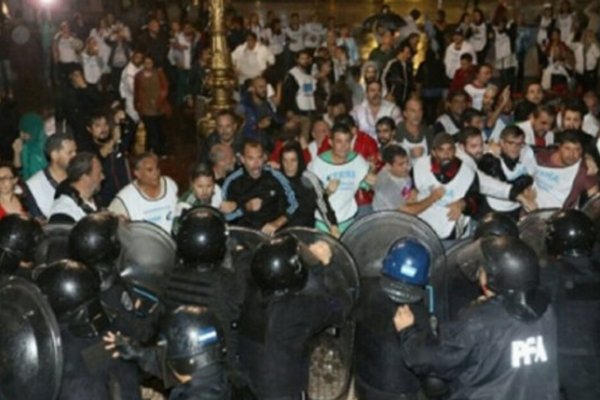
top-left (162, 306), bottom-right (225, 375)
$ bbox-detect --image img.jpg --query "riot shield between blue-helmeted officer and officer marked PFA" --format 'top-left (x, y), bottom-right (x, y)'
top-left (430, 239), bottom-right (482, 322)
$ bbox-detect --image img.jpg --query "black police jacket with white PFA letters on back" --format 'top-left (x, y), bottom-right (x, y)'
top-left (399, 296), bottom-right (558, 400)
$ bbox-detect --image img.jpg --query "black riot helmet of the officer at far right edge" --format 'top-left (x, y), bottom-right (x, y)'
top-left (546, 210), bottom-right (596, 257)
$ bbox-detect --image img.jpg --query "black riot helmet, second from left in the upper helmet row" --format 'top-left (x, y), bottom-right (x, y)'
top-left (69, 212), bottom-right (121, 266)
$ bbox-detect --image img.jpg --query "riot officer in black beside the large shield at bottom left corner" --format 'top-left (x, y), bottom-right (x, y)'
top-left (34, 260), bottom-right (141, 400)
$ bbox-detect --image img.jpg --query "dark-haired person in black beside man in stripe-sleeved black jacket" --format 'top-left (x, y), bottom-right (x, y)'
top-left (279, 142), bottom-right (340, 237)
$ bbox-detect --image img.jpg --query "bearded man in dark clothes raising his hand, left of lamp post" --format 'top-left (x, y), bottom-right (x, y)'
top-left (83, 110), bottom-right (131, 207)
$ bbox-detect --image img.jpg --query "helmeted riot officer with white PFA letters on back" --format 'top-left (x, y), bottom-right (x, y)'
top-left (394, 236), bottom-right (558, 400)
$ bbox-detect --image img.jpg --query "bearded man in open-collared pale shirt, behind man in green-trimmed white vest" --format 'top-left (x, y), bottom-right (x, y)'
top-left (352, 81), bottom-right (402, 140)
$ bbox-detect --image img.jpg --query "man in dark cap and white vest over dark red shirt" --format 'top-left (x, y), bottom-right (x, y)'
top-left (413, 133), bottom-right (480, 240)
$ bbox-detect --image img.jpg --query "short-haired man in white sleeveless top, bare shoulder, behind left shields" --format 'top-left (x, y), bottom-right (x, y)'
top-left (108, 153), bottom-right (177, 232)
